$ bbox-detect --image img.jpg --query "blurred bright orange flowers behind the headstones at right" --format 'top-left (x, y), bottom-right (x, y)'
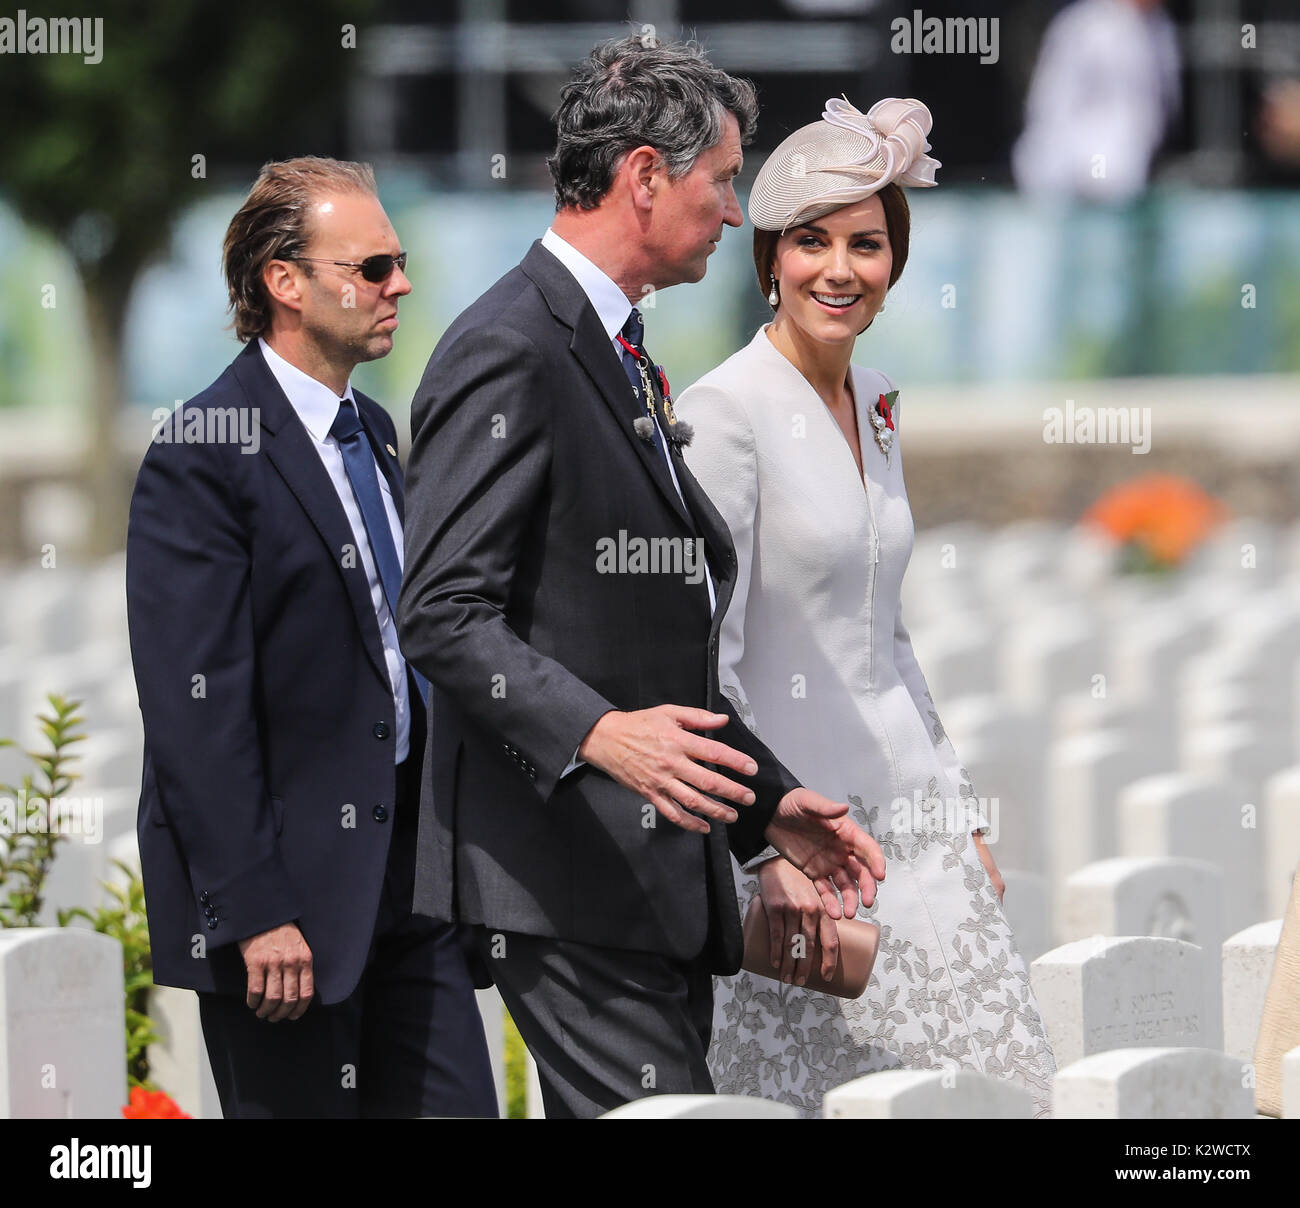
top-left (1083, 475), bottom-right (1225, 566)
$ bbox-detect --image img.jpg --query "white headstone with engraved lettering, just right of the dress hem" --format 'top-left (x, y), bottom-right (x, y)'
top-left (1030, 936), bottom-right (1205, 1068)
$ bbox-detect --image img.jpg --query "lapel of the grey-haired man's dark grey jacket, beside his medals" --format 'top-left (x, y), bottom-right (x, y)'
top-left (521, 242), bottom-right (694, 532)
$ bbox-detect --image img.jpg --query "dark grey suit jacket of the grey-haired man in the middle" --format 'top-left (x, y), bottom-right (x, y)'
top-left (398, 243), bottom-right (798, 971)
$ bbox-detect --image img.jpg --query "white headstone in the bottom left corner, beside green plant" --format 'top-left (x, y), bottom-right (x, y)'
top-left (0, 927), bottom-right (126, 1120)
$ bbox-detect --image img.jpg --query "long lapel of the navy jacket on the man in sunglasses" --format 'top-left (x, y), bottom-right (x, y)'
top-left (234, 343), bottom-right (389, 684)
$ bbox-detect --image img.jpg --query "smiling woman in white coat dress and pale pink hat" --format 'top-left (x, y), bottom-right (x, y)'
top-left (677, 99), bottom-right (1056, 1116)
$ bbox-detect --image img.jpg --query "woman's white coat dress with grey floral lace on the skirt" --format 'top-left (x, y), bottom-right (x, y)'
top-left (676, 328), bottom-right (1056, 1116)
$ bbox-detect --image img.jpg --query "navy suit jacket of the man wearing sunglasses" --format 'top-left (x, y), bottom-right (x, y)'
top-left (126, 342), bottom-right (425, 1003)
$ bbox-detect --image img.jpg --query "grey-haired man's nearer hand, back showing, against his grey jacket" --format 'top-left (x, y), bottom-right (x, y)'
top-left (577, 705), bottom-right (759, 835)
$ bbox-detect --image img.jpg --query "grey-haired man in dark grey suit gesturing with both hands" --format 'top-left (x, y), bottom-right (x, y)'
top-left (398, 38), bottom-right (884, 1117)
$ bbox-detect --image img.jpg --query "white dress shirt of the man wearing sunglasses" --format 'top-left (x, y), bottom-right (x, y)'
top-left (257, 338), bottom-right (411, 763)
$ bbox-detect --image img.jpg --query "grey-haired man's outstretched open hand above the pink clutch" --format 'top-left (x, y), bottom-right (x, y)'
top-left (764, 788), bottom-right (885, 918)
